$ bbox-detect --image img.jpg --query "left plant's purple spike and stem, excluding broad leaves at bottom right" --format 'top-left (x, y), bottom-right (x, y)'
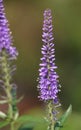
top-left (0, 0), bottom-right (18, 130)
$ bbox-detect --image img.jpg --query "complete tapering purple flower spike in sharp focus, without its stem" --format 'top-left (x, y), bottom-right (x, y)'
top-left (38, 9), bottom-right (59, 104)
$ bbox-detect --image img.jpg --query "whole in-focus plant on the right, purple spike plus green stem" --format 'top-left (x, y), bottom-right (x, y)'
top-left (38, 9), bottom-right (72, 130)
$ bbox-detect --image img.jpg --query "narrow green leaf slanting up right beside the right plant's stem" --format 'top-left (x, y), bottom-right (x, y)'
top-left (54, 105), bottom-right (72, 130)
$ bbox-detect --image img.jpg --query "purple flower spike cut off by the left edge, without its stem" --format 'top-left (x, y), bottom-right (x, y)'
top-left (0, 0), bottom-right (18, 58)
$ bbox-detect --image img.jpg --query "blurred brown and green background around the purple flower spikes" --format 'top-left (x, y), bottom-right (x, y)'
top-left (1, 0), bottom-right (81, 130)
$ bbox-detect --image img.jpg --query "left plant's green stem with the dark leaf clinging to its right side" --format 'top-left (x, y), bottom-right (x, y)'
top-left (0, 50), bottom-right (18, 130)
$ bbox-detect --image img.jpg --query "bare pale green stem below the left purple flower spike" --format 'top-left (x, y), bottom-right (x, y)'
top-left (1, 50), bottom-right (18, 130)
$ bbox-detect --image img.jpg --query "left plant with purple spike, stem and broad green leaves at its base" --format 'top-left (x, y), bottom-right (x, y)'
top-left (0, 0), bottom-right (43, 130)
